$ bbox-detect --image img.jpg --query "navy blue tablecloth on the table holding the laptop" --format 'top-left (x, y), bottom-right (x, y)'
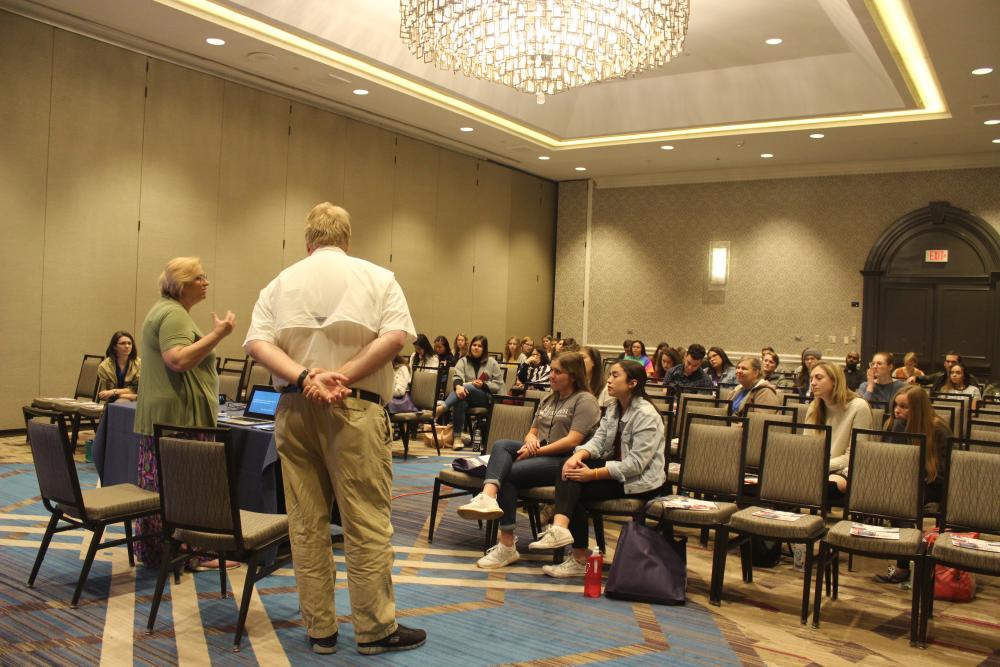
top-left (93, 401), bottom-right (280, 514)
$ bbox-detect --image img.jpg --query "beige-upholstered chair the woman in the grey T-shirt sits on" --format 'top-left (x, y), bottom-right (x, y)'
top-left (427, 396), bottom-right (538, 550)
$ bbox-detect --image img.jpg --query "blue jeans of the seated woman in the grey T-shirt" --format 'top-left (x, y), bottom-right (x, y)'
top-left (484, 440), bottom-right (570, 530)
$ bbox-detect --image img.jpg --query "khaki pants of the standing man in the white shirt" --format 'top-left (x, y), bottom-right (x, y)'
top-left (275, 394), bottom-right (396, 642)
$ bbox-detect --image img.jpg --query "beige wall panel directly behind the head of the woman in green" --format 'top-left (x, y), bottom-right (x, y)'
top-left (136, 60), bottom-right (225, 335)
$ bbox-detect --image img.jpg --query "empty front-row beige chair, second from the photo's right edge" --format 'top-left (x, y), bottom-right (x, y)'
top-left (807, 429), bottom-right (927, 646)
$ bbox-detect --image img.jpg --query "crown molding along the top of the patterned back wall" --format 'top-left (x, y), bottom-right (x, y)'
top-left (595, 153), bottom-right (1000, 190)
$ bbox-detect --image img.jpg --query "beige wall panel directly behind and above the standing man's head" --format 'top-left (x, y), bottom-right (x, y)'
top-left (283, 103), bottom-right (350, 266)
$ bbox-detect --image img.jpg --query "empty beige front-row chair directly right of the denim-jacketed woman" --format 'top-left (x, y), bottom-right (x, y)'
top-left (648, 412), bottom-right (748, 605)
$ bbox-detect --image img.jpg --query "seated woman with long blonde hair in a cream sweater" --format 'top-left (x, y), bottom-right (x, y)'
top-left (806, 361), bottom-right (872, 494)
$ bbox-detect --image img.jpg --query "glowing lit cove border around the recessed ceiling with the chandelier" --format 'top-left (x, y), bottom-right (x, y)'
top-left (155, 0), bottom-right (951, 151)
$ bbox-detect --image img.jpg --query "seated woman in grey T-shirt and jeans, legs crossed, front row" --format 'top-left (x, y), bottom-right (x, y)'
top-left (458, 349), bottom-right (601, 569)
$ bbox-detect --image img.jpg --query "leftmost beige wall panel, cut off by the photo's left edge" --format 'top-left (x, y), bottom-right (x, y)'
top-left (0, 12), bottom-right (52, 429)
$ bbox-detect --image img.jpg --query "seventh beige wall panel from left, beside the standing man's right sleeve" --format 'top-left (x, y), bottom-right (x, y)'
top-left (387, 137), bottom-right (441, 332)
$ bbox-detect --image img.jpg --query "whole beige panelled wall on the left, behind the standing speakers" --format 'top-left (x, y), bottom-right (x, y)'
top-left (0, 12), bottom-right (556, 429)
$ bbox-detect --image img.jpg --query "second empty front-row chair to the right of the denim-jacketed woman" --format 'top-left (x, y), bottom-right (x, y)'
top-left (719, 421), bottom-right (831, 623)
